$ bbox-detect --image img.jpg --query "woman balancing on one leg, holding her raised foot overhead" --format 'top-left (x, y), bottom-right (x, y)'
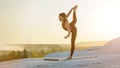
top-left (59, 5), bottom-right (78, 60)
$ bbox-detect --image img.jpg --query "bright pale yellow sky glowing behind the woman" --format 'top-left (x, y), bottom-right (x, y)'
top-left (0, 0), bottom-right (120, 44)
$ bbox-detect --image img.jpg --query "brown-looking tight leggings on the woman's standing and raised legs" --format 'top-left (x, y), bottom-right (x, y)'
top-left (70, 10), bottom-right (77, 56)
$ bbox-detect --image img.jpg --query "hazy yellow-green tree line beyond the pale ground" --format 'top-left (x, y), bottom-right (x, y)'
top-left (0, 47), bottom-right (88, 62)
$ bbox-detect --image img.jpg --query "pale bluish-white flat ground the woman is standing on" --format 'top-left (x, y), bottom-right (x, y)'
top-left (0, 47), bottom-right (120, 68)
